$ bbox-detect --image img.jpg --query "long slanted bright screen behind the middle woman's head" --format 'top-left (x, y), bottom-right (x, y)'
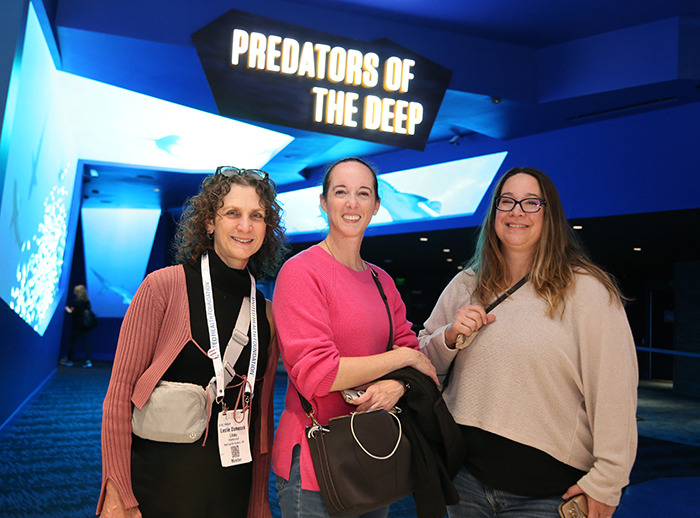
top-left (278, 151), bottom-right (507, 241)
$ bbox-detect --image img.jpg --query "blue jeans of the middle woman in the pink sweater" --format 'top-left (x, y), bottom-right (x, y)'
top-left (275, 444), bottom-right (389, 518)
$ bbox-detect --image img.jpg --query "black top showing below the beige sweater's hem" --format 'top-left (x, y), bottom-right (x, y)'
top-left (460, 425), bottom-right (586, 498)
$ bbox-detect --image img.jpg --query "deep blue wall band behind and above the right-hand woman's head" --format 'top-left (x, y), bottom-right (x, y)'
top-left (360, 98), bottom-right (700, 239)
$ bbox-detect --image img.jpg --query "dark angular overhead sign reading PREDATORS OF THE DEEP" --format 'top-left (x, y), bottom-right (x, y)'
top-left (192, 10), bottom-right (452, 150)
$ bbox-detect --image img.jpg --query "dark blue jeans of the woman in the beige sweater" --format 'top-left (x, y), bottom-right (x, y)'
top-left (447, 467), bottom-right (563, 518)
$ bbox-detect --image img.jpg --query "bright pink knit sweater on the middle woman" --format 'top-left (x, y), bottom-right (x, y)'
top-left (272, 246), bottom-right (418, 491)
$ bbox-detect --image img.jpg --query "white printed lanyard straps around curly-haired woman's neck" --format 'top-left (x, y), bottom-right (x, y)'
top-left (202, 253), bottom-right (259, 403)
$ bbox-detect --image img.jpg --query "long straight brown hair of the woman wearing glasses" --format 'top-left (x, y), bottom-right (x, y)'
top-left (468, 167), bottom-right (624, 317)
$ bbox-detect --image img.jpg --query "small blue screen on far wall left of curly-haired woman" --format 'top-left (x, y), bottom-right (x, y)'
top-left (81, 208), bottom-right (160, 318)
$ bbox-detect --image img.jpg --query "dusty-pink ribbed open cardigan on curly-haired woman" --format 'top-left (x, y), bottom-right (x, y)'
top-left (97, 266), bottom-right (279, 518)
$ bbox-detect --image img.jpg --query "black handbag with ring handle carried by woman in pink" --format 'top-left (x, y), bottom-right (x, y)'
top-left (297, 270), bottom-right (413, 517)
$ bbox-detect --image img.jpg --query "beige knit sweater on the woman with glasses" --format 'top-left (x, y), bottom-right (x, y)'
top-left (418, 270), bottom-right (638, 505)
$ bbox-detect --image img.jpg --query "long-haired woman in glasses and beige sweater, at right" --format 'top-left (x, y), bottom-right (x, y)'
top-left (419, 167), bottom-right (638, 518)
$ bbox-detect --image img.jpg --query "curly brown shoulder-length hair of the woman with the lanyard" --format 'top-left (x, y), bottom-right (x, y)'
top-left (173, 167), bottom-right (288, 279)
